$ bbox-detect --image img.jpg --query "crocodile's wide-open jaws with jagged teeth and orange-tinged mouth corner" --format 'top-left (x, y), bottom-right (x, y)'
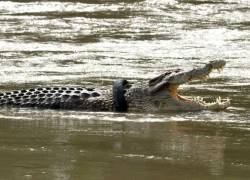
top-left (148, 60), bottom-right (230, 110)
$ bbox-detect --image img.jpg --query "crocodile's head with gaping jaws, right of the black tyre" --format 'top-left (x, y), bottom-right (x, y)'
top-left (126, 60), bottom-right (230, 112)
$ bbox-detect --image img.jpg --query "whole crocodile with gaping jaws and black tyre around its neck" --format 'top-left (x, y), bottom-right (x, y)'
top-left (0, 60), bottom-right (230, 112)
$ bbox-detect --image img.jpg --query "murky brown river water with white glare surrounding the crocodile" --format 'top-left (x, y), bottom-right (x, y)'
top-left (0, 0), bottom-right (250, 180)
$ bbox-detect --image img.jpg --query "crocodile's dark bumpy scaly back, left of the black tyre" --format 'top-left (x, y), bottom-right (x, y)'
top-left (0, 87), bottom-right (112, 111)
